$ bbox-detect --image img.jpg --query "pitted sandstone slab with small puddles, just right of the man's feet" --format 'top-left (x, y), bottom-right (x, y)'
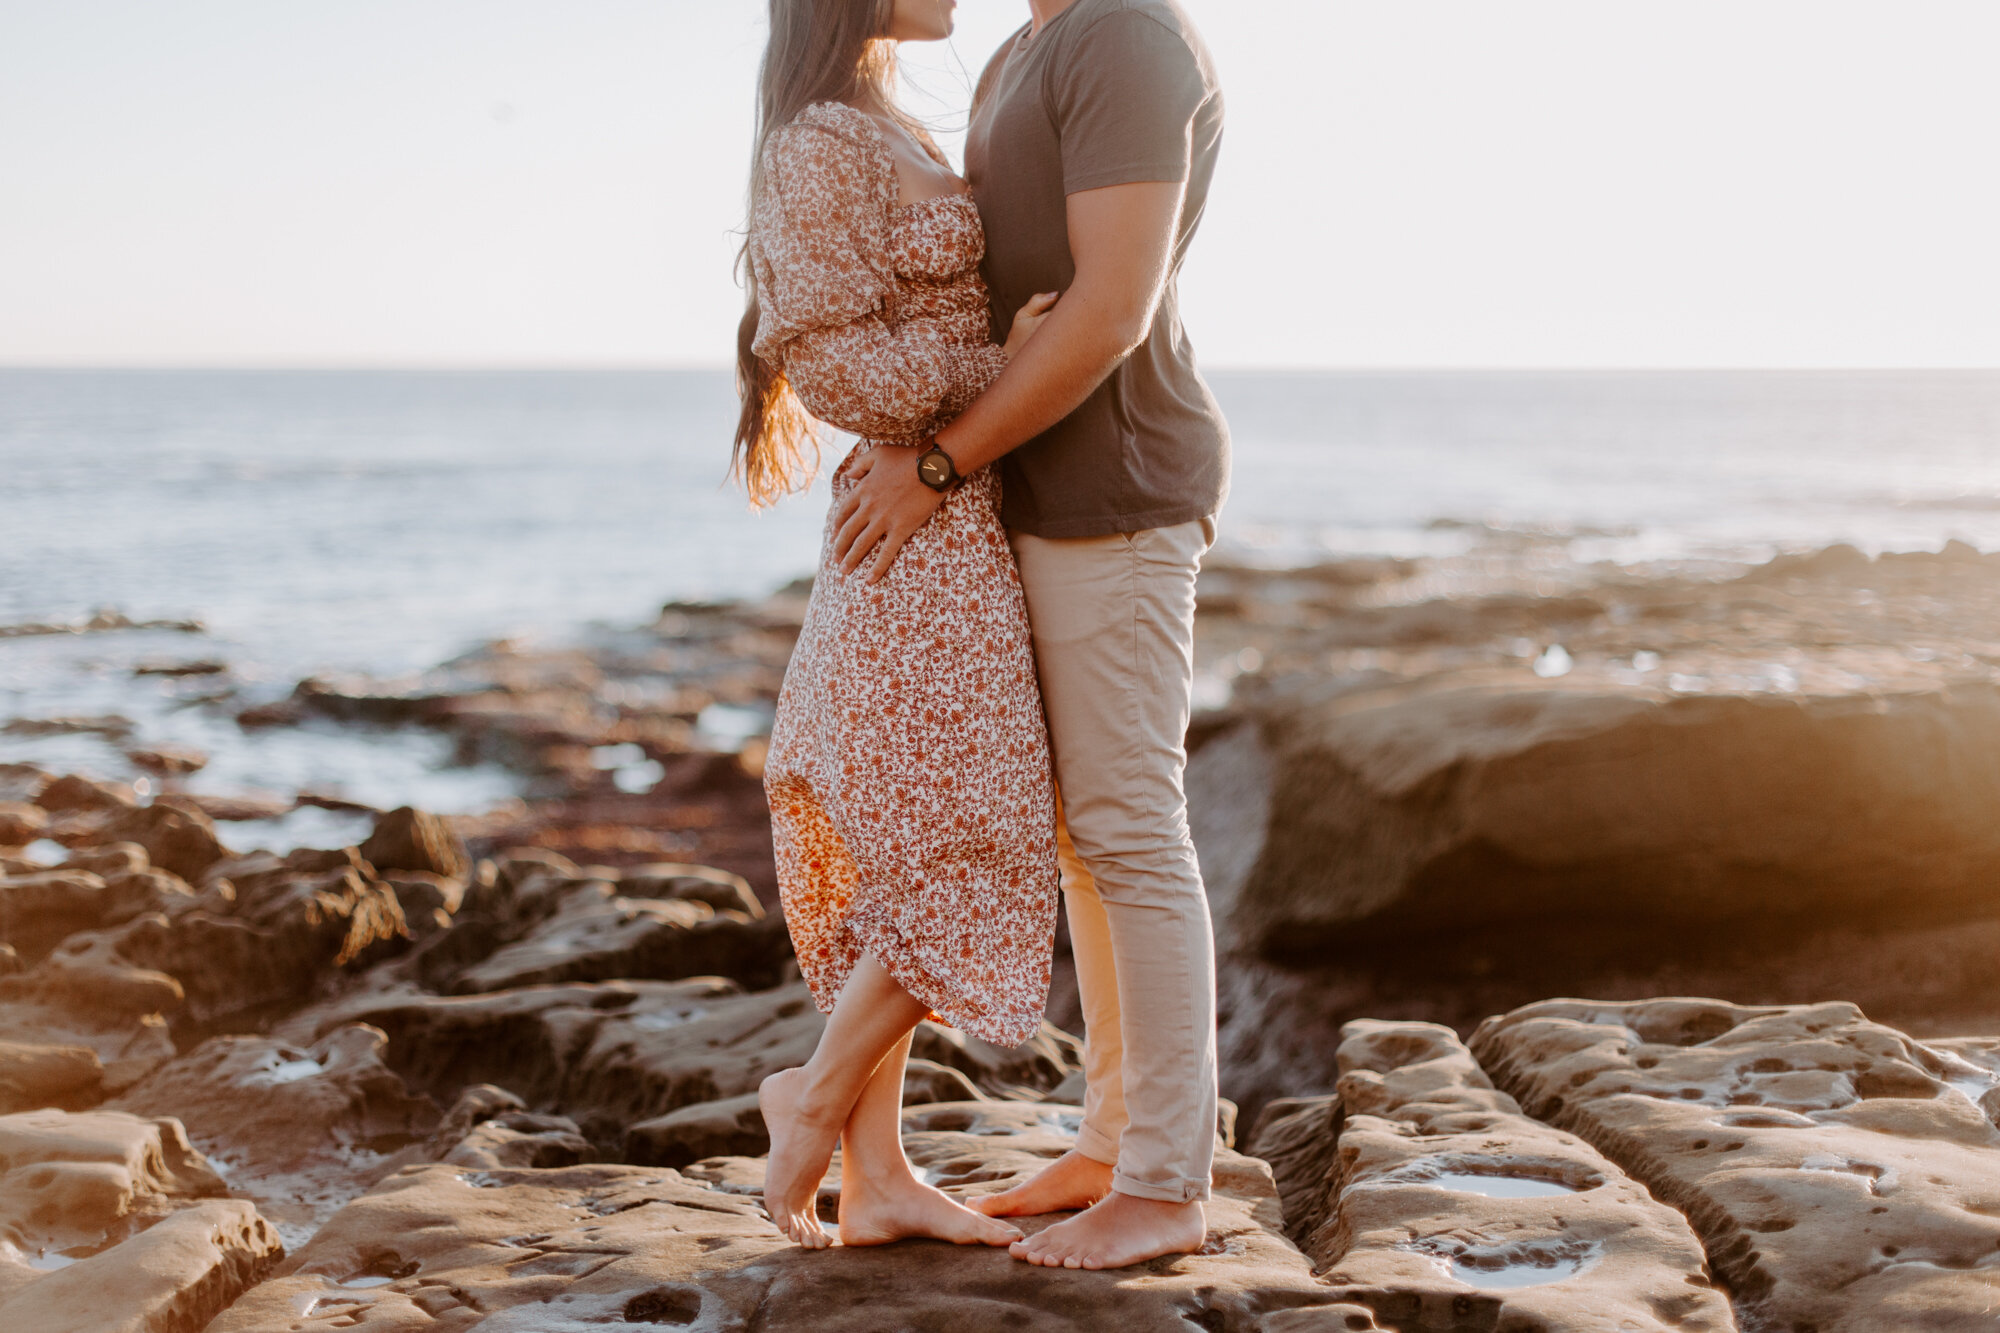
top-left (1272, 1021), bottom-right (1736, 1333)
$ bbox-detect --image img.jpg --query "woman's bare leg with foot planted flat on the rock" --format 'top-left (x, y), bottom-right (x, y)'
top-left (840, 1033), bottom-right (1020, 1245)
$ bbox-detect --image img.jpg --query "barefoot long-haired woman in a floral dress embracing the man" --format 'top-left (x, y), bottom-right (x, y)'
top-left (736, 0), bottom-right (1056, 1247)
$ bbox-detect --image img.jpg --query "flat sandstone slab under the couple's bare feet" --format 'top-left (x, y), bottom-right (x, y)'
top-left (210, 1103), bottom-right (1374, 1333)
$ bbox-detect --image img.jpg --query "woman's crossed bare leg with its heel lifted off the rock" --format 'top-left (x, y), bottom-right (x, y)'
top-left (758, 955), bottom-right (928, 1249)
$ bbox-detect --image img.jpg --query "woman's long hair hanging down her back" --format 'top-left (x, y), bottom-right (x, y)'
top-left (730, 0), bottom-right (896, 506)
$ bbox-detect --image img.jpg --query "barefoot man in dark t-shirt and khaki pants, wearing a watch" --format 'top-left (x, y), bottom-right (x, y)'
top-left (836, 0), bottom-right (1228, 1269)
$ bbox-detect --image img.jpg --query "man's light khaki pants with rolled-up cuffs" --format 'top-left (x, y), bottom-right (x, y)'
top-left (1010, 518), bottom-right (1216, 1203)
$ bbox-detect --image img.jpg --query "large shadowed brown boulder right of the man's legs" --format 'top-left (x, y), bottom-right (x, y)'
top-left (1216, 671), bottom-right (2000, 957)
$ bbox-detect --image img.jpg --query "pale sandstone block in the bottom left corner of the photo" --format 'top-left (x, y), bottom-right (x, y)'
top-left (0, 1199), bottom-right (284, 1333)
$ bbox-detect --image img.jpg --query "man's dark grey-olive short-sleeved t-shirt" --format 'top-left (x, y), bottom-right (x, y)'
top-left (966, 0), bottom-right (1230, 536)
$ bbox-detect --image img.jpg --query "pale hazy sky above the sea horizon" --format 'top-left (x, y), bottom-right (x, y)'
top-left (0, 0), bottom-right (2000, 366)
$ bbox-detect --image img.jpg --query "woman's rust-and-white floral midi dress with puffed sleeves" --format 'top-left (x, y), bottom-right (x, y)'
top-left (750, 102), bottom-right (1058, 1045)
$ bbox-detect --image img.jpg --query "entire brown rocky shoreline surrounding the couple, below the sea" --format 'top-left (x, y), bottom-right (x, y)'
top-left (0, 532), bottom-right (2000, 1333)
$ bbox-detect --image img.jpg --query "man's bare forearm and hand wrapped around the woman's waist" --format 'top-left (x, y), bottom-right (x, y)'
top-left (834, 182), bottom-right (1184, 582)
